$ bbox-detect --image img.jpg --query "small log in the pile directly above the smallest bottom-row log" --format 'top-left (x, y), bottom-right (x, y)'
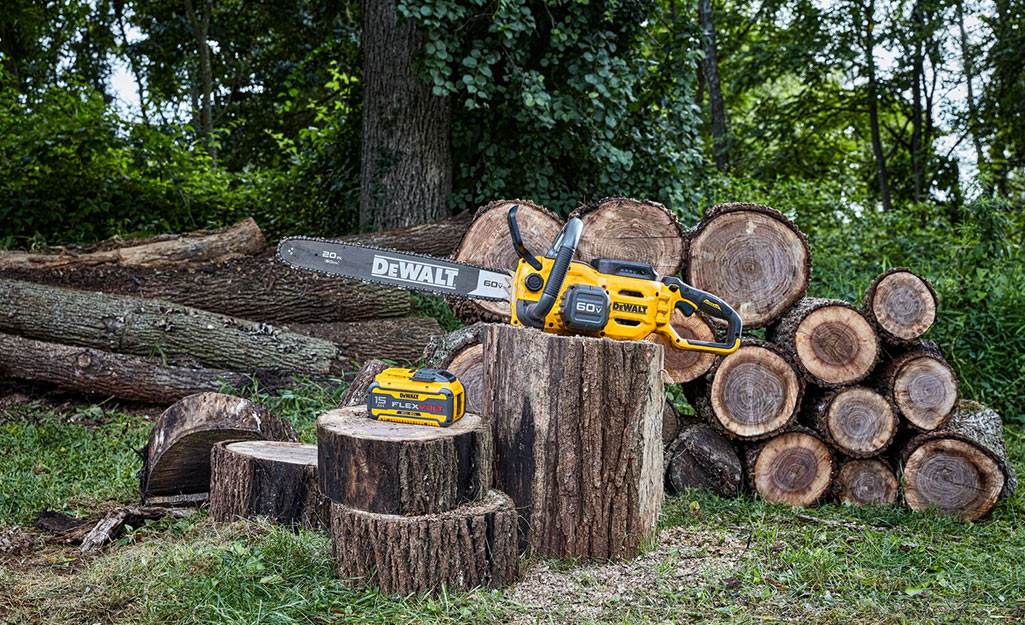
top-left (808, 386), bottom-right (900, 458)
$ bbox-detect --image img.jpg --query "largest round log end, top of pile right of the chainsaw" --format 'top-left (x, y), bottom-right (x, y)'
top-left (687, 204), bottom-right (812, 329)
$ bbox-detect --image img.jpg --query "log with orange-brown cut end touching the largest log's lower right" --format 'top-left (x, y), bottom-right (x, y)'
top-left (770, 297), bottom-right (879, 387)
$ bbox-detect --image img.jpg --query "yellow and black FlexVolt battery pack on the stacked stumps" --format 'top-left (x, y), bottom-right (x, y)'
top-left (367, 367), bottom-right (466, 427)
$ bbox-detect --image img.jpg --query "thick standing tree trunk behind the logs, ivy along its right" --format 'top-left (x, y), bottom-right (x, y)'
top-left (360, 0), bottom-right (452, 230)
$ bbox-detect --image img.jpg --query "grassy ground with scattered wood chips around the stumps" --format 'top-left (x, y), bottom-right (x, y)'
top-left (0, 389), bottom-right (1025, 624)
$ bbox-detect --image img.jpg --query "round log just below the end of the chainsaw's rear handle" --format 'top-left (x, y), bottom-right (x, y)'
top-left (695, 338), bottom-right (805, 441)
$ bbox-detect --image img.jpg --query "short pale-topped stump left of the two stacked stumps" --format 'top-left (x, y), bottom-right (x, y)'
top-left (210, 441), bottom-right (328, 529)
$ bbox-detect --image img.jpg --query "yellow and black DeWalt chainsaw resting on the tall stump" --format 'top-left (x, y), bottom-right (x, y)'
top-left (278, 205), bottom-right (742, 355)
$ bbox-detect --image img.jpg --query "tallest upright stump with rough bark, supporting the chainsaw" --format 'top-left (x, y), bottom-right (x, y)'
top-left (484, 325), bottom-right (665, 559)
